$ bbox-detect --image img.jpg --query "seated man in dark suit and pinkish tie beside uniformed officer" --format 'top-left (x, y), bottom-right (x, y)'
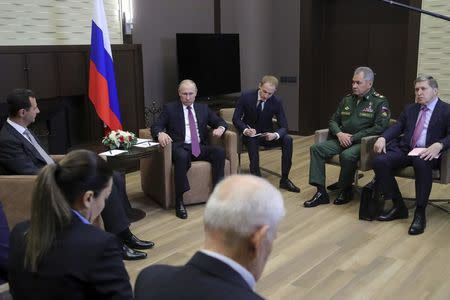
top-left (373, 75), bottom-right (450, 235)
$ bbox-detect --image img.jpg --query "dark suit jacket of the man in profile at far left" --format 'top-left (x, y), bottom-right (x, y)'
top-left (0, 123), bottom-right (47, 175)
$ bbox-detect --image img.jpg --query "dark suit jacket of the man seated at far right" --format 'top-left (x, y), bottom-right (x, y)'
top-left (382, 99), bottom-right (450, 152)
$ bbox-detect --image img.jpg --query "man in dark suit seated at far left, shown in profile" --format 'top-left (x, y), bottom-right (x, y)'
top-left (0, 89), bottom-right (154, 260)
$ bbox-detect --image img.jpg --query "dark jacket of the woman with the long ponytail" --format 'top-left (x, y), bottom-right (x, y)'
top-left (8, 215), bottom-right (133, 300)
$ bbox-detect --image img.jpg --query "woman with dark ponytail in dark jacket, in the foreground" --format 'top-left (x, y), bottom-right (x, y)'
top-left (8, 150), bottom-right (133, 300)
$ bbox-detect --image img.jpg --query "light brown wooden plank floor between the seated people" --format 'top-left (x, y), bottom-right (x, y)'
top-left (126, 137), bottom-right (450, 299)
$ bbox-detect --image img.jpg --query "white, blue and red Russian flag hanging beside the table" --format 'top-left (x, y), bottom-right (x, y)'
top-left (89, 0), bottom-right (122, 130)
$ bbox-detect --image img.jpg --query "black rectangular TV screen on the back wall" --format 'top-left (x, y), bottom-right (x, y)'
top-left (177, 33), bottom-right (241, 97)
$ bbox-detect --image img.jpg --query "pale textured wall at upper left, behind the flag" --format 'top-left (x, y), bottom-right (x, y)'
top-left (0, 0), bottom-right (123, 46)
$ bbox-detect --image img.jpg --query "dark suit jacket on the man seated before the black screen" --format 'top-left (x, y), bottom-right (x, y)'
top-left (151, 101), bottom-right (227, 149)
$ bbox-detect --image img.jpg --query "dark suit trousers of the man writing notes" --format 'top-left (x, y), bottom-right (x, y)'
top-left (242, 134), bottom-right (292, 178)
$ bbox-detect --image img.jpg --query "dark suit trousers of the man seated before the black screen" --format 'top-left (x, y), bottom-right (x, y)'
top-left (172, 144), bottom-right (225, 200)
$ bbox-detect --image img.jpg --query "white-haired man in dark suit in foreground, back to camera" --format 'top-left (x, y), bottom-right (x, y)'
top-left (135, 175), bottom-right (285, 300)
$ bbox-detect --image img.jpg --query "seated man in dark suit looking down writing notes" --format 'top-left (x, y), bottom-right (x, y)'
top-left (233, 75), bottom-right (300, 193)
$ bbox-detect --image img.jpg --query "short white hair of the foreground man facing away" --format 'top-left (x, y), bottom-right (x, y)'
top-left (203, 175), bottom-right (286, 240)
